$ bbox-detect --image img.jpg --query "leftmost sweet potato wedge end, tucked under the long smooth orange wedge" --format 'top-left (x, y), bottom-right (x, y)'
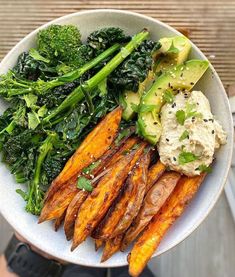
top-left (38, 177), bottom-right (79, 223)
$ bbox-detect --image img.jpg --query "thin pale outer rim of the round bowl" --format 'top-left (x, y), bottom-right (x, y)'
top-left (0, 8), bottom-right (234, 268)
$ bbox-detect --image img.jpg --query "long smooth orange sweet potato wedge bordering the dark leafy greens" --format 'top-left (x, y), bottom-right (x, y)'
top-left (45, 107), bottom-right (122, 200)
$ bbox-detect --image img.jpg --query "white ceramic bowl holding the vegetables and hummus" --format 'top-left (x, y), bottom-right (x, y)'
top-left (0, 9), bottom-right (233, 267)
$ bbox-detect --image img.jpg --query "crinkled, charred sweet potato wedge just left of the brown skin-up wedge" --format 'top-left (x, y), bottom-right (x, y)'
top-left (95, 152), bottom-right (150, 239)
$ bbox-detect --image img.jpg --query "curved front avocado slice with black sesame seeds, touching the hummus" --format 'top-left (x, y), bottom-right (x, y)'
top-left (137, 60), bottom-right (209, 145)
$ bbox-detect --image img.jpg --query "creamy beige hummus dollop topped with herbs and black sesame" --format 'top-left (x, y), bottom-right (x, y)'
top-left (158, 91), bottom-right (226, 176)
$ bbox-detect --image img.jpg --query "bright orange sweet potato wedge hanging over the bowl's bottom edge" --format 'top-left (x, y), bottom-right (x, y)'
top-left (128, 174), bottom-right (205, 277)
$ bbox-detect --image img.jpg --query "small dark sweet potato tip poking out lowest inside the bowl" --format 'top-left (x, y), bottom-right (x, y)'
top-left (101, 234), bottom-right (123, 263)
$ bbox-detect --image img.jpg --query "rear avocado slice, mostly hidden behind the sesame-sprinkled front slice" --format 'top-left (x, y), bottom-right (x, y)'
top-left (120, 36), bottom-right (191, 121)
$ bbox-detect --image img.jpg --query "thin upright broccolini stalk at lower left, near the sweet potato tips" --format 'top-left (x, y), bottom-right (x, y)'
top-left (26, 133), bottom-right (56, 215)
